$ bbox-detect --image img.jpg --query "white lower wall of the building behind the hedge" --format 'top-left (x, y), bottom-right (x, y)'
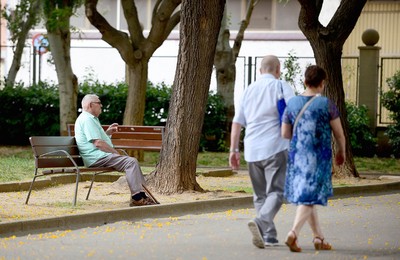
top-left (5, 33), bottom-right (313, 108)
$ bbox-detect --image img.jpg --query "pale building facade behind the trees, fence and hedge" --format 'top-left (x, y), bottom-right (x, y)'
top-left (0, 0), bottom-right (400, 112)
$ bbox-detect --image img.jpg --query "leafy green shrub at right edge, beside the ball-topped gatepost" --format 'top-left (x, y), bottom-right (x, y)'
top-left (381, 70), bottom-right (400, 157)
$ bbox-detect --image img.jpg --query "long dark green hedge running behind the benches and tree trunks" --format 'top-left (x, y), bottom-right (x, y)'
top-left (0, 80), bottom-right (382, 156)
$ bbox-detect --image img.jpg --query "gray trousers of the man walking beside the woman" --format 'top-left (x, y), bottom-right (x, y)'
top-left (248, 150), bottom-right (288, 241)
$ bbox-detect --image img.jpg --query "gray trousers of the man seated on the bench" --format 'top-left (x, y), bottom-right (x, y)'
top-left (90, 153), bottom-right (145, 195)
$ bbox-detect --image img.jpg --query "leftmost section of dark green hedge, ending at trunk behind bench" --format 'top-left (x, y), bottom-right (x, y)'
top-left (0, 82), bottom-right (60, 145)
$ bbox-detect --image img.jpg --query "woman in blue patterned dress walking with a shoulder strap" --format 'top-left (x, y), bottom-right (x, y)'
top-left (281, 65), bottom-right (346, 252)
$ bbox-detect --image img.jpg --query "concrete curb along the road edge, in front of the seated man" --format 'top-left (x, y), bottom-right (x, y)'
top-left (0, 176), bottom-right (400, 237)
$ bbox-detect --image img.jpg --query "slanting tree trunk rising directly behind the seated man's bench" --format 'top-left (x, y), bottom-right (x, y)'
top-left (45, 1), bottom-right (78, 135)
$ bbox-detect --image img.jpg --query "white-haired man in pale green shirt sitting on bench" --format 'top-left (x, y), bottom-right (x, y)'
top-left (75, 94), bottom-right (156, 207)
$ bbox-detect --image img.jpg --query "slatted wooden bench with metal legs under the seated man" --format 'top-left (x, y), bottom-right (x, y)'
top-left (25, 136), bottom-right (158, 206)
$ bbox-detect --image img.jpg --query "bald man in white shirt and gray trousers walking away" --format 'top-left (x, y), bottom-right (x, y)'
top-left (229, 55), bottom-right (294, 248)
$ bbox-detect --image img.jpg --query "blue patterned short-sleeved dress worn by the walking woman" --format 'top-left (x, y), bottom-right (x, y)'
top-left (283, 96), bottom-right (339, 206)
